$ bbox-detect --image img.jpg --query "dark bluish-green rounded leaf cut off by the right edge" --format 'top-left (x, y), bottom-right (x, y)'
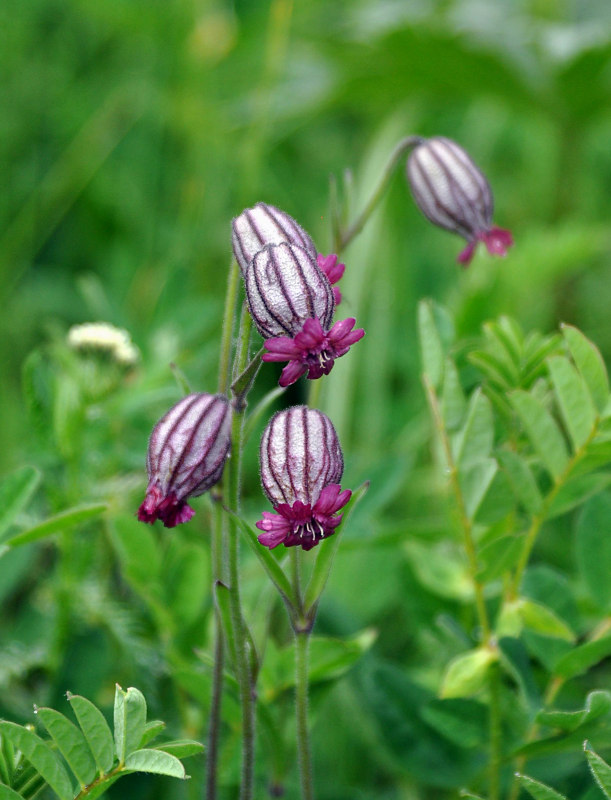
top-left (576, 493), bottom-right (611, 609)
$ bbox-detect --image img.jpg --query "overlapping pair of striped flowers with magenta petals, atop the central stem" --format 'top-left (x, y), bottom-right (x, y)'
top-left (233, 203), bottom-right (365, 386)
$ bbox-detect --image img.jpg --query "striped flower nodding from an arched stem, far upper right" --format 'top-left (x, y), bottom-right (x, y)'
top-left (407, 136), bottom-right (513, 266)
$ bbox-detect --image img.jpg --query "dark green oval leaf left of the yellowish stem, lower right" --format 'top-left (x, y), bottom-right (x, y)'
top-left (421, 697), bottom-right (488, 748)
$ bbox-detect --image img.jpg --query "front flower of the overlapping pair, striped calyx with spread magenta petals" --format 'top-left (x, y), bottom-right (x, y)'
top-left (245, 242), bottom-right (365, 386)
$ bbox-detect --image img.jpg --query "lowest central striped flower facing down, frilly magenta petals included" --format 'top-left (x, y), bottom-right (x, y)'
top-left (257, 406), bottom-right (352, 550)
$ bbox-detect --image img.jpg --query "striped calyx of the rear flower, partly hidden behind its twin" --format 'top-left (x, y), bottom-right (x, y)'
top-left (231, 203), bottom-right (316, 275)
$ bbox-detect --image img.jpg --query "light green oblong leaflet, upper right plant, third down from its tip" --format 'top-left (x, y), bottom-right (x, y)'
top-left (510, 390), bottom-right (569, 478)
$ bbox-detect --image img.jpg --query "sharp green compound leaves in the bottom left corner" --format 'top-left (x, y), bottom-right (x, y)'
top-left (0, 686), bottom-right (203, 800)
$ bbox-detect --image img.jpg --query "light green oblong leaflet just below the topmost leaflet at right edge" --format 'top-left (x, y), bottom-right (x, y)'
top-left (547, 356), bottom-right (596, 450)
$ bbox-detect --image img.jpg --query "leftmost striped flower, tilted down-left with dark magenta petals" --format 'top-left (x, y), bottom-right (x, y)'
top-left (138, 393), bottom-right (231, 528)
